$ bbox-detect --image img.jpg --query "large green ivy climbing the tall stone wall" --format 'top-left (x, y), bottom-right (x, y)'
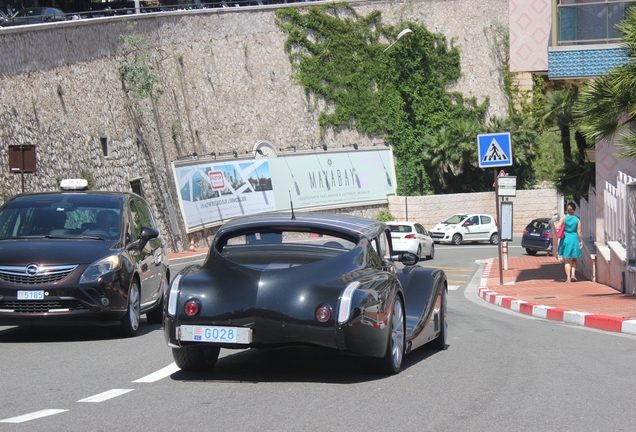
top-left (276, 3), bottom-right (488, 195)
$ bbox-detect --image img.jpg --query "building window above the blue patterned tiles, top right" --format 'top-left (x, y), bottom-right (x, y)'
top-left (552, 0), bottom-right (636, 45)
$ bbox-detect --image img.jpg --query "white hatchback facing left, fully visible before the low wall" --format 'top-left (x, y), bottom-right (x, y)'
top-left (429, 213), bottom-right (499, 245)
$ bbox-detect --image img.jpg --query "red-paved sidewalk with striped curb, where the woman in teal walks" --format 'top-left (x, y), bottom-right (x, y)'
top-left (478, 256), bottom-right (636, 335)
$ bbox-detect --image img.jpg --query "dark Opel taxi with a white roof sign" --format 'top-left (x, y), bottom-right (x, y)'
top-left (0, 180), bottom-right (169, 336)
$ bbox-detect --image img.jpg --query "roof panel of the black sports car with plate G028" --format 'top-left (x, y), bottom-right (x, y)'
top-left (215, 212), bottom-right (386, 241)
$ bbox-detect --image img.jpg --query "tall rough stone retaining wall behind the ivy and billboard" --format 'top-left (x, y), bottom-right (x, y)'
top-left (0, 0), bottom-right (508, 250)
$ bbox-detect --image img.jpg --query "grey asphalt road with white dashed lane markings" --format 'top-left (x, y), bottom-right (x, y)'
top-left (0, 244), bottom-right (636, 431)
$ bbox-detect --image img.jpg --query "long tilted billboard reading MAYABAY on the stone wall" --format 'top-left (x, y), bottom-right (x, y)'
top-left (173, 147), bottom-right (395, 232)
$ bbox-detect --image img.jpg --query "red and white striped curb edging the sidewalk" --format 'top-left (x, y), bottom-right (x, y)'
top-left (479, 261), bottom-right (636, 335)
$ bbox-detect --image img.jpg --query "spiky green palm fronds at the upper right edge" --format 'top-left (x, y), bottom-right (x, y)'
top-left (574, 7), bottom-right (636, 158)
